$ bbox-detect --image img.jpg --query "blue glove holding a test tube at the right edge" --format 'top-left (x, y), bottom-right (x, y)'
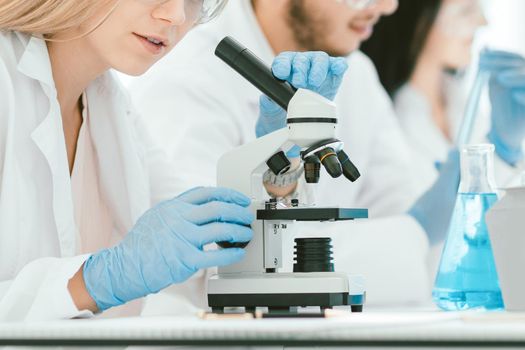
top-left (480, 50), bottom-right (525, 165)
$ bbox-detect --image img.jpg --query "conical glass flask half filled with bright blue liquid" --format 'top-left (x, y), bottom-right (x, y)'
top-left (432, 144), bottom-right (503, 311)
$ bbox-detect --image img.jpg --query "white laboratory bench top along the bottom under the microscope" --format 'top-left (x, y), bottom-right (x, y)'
top-left (0, 311), bottom-right (525, 349)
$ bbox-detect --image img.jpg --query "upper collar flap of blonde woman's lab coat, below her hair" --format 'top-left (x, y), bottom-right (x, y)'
top-left (16, 32), bottom-right (55, 91)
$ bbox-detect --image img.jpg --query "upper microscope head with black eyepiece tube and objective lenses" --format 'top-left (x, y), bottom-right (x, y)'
top-left (215, 37), bottom-right (360, 191)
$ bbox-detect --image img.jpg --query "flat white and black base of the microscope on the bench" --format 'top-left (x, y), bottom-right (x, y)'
top-left (208, 272), bottom-right (365, 312)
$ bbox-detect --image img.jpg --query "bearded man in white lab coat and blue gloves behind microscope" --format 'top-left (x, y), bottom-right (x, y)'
top-left (130, 0), bottom-right (459, 312)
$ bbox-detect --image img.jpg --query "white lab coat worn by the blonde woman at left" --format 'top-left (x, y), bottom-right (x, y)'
top-left (0, 32), bottom-right (179, 321)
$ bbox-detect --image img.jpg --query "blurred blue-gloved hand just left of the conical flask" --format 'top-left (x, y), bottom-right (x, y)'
top-left (408, 150), bottom-right (460, 244)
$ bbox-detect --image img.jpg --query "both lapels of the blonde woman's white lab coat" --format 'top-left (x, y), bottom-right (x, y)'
top-left (10, 33), bottom-right (150, 257)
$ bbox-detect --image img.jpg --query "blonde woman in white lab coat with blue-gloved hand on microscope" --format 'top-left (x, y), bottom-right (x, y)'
top-left (0, 0), bottom-right (344, 320)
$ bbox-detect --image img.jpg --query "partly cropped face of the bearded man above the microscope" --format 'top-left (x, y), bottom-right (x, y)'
top-left (289, 0), bottom-right (398, 56)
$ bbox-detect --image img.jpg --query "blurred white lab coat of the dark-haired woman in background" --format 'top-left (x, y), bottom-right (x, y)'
top-left (394, 75), bottom-right (525, 280)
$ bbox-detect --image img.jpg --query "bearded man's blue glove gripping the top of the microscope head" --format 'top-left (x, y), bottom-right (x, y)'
top-left (255, 52), bottom-right (348, 158)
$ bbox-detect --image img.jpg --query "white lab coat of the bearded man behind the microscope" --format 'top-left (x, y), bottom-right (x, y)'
top-left (130, 0), bottom-right (429, 304)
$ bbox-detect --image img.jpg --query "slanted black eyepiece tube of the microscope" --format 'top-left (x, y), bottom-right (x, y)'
top-left (215, 36), bottom-right (297, 111)
